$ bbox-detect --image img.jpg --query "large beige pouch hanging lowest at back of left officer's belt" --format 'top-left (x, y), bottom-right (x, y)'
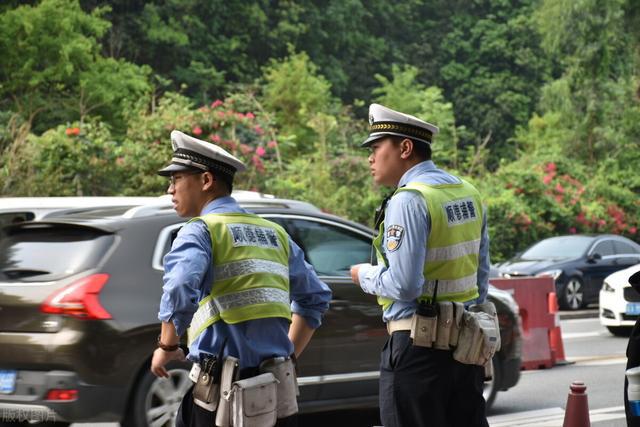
top-left (229, 372), bottom-right (278, 427)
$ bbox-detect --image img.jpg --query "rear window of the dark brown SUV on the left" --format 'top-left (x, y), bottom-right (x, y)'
top-left (0, 224), bottom-right (113, 282)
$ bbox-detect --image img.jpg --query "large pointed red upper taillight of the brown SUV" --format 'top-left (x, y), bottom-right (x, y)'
top-left (40, 273), bottom-right (111, 319)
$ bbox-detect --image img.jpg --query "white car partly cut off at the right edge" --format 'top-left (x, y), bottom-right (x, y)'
top-left (600, 264), bottom-right (640, 336)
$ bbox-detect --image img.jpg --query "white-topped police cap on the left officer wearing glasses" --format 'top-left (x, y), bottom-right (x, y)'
top-left (158, 130), bottom-right (246, 181)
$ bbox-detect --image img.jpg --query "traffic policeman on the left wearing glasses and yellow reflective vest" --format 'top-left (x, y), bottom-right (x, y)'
top-left (151, 131), bottom-right (331, 427)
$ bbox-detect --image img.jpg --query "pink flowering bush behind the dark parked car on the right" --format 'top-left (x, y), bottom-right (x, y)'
top-left (476, 156), bottom-right (640, 262)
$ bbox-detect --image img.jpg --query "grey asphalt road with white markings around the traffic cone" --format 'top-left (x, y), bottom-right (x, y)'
top-left (73, 310), bottom-right (627, 427)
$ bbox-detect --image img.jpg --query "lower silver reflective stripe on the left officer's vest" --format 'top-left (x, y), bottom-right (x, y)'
top-left (189, 288), bottom-right (290, 340)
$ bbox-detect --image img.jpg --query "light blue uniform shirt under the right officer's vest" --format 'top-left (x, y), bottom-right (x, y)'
top-left (358, 160), bottom-right (490, 322)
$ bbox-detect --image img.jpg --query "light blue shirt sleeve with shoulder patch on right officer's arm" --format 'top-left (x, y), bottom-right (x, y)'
top-left (358, 191), bottom-right (429, 301)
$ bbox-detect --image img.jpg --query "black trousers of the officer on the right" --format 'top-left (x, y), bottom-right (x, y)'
top-left (380, 331), bottom-right (489, 427)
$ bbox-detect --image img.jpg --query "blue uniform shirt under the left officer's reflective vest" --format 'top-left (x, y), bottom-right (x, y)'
top-left (158, 197), bottom-right (331, 368)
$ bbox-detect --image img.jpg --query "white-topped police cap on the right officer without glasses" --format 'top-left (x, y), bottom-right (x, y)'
top-left (362, 104), bottom-right (439, 147)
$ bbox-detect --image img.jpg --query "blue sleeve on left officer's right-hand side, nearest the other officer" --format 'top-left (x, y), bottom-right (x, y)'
top-left (289, 239), bottom-right (331, 329)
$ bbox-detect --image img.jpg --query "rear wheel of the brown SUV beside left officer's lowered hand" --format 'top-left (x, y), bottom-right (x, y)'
top-left (121, 362), bottom-right (193, 427)
